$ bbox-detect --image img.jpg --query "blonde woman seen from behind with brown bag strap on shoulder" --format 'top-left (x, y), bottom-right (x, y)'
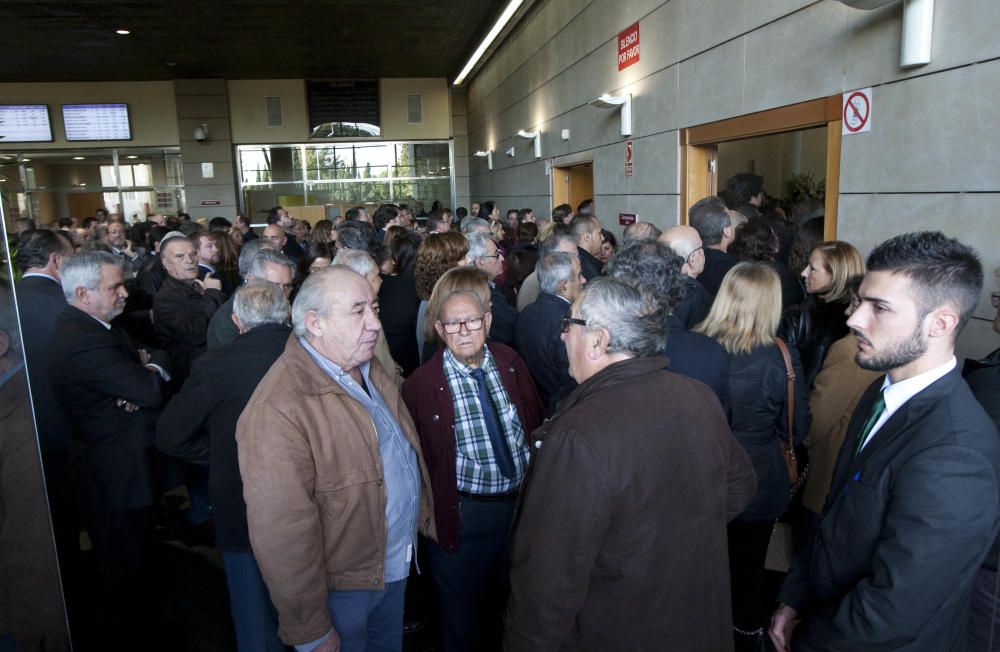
top-left (695, 263), bottom-right (810, 651)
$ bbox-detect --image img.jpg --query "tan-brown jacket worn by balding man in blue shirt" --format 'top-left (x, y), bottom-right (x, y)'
top-left (236, 337), bottom-right (435, 645)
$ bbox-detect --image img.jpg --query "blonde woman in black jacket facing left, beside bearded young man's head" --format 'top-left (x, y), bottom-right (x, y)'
top-left (780, 240), bottom-right (865, 387)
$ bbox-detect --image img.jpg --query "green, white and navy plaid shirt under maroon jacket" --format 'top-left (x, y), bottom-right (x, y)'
top-left (444, 347), bottom-right (528, 494)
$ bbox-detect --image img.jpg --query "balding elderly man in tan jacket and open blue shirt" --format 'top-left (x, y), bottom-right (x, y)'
top-left (236, 266), bottom-right (434, 652)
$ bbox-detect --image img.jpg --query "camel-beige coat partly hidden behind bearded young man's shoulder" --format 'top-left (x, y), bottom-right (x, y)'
top-left (802, 335), bottom-right (881, 514)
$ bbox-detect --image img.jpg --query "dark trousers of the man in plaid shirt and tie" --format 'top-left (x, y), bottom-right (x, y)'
top-left (427, 496), bottom-right (517, 652)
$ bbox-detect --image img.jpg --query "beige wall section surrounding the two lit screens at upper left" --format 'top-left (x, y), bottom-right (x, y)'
top-left (0, 82), bottom-right (179, 151)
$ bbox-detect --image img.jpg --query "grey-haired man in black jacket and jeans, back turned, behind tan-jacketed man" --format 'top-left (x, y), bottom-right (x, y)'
top-left (156, 282), bottom-right (291, 651)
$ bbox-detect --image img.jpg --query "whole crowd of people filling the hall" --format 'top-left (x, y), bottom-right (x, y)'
top-left (7, 174), bottom-right (1000, 652)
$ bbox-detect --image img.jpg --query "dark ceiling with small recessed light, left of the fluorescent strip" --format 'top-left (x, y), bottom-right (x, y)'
top-left (0, 0), bottom-right (506, 82)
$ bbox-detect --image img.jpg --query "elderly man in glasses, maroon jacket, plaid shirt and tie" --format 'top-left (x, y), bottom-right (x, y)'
top-left (403, 290), bottom-right (544, 652)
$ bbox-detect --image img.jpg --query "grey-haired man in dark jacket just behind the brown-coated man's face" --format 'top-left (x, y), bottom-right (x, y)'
top-left (517, 252), bottom-right (587, 415)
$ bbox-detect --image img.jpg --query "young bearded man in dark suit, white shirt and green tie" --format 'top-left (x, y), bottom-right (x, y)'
top-left (770, 232), bottom-right (1000, 652)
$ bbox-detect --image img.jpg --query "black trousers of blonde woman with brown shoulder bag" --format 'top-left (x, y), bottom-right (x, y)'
top-left (728, 521), bottom-right (774, 631)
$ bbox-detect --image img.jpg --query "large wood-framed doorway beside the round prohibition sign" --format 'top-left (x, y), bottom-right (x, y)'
top-left (681, 95), bottom-right (841, 240)
